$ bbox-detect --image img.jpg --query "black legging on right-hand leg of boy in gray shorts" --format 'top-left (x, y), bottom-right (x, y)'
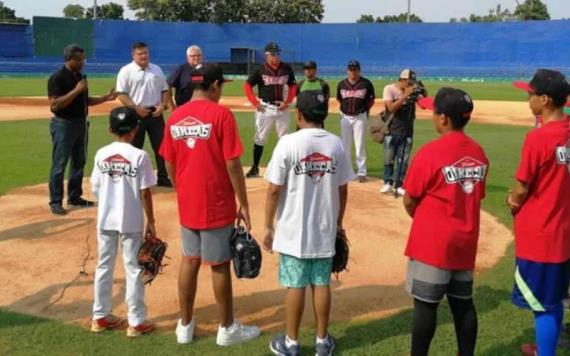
top-left (447, 295), bottom-right (478, 356)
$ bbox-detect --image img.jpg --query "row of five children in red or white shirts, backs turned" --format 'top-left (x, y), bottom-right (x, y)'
top-left (85, 64), bottom-right (570, 356)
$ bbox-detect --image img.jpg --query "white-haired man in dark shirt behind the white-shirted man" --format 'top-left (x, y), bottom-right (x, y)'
top-left (167, 45), bottom-right (203, 109)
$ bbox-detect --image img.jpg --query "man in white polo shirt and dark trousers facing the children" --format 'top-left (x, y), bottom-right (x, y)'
top-left (116, 42), bottom-right (172, 187)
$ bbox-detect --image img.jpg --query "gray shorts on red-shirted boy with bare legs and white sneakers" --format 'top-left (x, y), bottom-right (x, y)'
top-left (182, 225), bottom-right (234, 266)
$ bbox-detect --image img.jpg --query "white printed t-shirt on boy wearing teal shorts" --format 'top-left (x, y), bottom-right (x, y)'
top-left (265, 128), bottom-right (354, 258)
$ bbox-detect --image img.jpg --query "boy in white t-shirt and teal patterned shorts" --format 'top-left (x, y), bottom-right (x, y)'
top-left (263, 91), bottom-right (355, 356)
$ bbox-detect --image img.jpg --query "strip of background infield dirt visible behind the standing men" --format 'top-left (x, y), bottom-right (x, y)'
top-left (0, 97), bottom-right (534, 126)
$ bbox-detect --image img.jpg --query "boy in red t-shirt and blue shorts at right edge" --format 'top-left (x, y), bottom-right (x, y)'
top-left (507, 69), bottom-right (570, 356)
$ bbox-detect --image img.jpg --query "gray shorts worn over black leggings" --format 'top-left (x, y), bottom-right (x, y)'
top-left (406, 259), bottom-right (473, 303)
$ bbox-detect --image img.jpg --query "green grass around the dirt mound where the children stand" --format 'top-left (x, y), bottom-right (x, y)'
top-left (0, 113), bottom-right (570, 356)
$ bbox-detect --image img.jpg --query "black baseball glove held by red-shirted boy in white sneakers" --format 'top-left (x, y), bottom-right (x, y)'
top-left (230, 226), bottom-right (261, 278)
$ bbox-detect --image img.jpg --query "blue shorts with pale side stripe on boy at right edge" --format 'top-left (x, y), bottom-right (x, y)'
top-left (512, 258), bottom-right (570, 312)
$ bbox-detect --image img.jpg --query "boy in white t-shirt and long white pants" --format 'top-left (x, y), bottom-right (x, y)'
top-left (91, 107), bottom-right (156, 337)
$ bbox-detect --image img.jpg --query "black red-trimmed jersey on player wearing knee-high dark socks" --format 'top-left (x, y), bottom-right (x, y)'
top-left (247, 62), bottom-right (296, 104)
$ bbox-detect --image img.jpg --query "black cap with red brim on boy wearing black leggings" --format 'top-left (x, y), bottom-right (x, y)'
top-left (418, 88), bottom-right (473, 119)
